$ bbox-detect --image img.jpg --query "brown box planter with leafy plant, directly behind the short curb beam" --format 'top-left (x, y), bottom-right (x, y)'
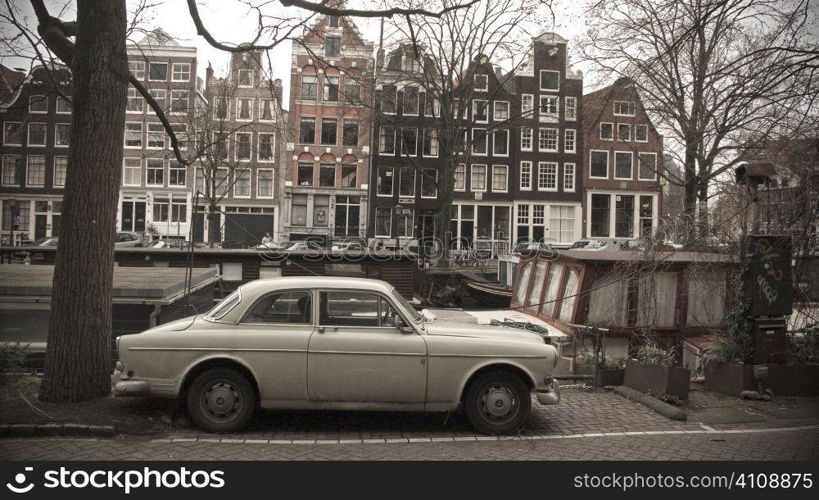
top-left (623, 338), bottom-right (691, 401)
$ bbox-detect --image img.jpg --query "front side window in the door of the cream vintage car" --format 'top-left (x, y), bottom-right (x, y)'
top-left (320, 292), bottom-right (398, 327)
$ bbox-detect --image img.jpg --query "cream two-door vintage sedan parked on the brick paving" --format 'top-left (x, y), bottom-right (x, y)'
top-left (112, 276), bottom-right (560, 434)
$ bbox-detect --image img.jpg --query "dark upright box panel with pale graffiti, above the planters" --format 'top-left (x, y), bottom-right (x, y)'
top-left (747, 235), bottom-right (793, 316)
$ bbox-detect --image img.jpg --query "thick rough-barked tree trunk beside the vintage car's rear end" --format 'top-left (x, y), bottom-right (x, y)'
top-left (39, 0), bottom-right (128, 401)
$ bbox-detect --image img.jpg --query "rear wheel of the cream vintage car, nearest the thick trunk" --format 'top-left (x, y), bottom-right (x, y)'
top-left (186, 368), bottom-right (257, 432)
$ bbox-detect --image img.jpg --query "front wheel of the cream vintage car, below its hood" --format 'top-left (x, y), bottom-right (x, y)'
top-left (464, 371), bottom-right (532, 434)
